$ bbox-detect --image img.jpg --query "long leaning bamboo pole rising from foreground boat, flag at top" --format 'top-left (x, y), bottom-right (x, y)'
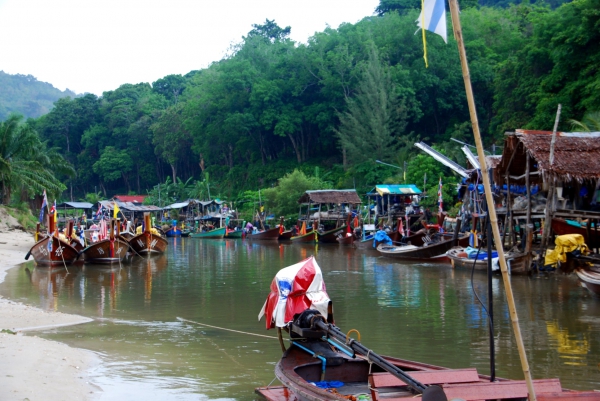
top-left (449, 0), bottom-right (537, 401)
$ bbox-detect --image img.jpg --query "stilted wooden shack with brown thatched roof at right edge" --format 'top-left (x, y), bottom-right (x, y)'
top-left (494, 129), bottom-right (600, 248)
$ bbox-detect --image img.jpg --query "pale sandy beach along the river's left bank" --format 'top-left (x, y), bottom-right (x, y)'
top-left (0, 209), bottom-right (101, 401)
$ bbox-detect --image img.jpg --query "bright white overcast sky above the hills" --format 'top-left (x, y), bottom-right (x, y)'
top-left (0, 0), bottom-right (379, 95)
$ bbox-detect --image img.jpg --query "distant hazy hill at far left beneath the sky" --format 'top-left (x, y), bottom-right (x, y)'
top-left (0, 71), bottom-right (77, 121)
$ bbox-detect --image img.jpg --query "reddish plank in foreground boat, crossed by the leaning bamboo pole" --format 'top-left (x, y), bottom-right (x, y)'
top-left (443, 379), bottom-right (562, 401)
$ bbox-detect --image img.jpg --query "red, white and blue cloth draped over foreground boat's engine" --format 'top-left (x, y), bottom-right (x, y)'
top-left (258, 256), bottom-right (329, 329)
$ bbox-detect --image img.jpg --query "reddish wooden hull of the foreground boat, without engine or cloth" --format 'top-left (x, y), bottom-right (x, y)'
top-left (255, 340), bottom-right (600, 401)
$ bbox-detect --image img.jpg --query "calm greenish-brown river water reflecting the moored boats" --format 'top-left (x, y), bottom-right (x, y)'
top-left (0, 238), bottom-right (600, 401)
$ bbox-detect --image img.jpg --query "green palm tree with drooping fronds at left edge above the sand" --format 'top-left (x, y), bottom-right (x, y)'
top-left (0, 114), bottom-right (75, 204)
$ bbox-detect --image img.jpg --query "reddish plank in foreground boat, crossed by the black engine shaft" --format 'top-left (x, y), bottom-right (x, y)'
top-left (369, 368), bottom-right (479, 388)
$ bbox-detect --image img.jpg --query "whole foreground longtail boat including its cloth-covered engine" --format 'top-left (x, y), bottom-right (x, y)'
top-left (255, 257), bottom-right (600, 401)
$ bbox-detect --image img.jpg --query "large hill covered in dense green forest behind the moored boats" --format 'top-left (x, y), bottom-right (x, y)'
top-left (0, 0), bottom-right (600, 217)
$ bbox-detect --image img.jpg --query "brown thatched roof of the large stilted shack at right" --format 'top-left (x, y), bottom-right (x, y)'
top-left (495, 130), bottom-right (600, 182)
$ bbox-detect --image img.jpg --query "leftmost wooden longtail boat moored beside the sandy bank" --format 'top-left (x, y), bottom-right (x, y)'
top-left (25, 213), bottom-right (79, 266)
